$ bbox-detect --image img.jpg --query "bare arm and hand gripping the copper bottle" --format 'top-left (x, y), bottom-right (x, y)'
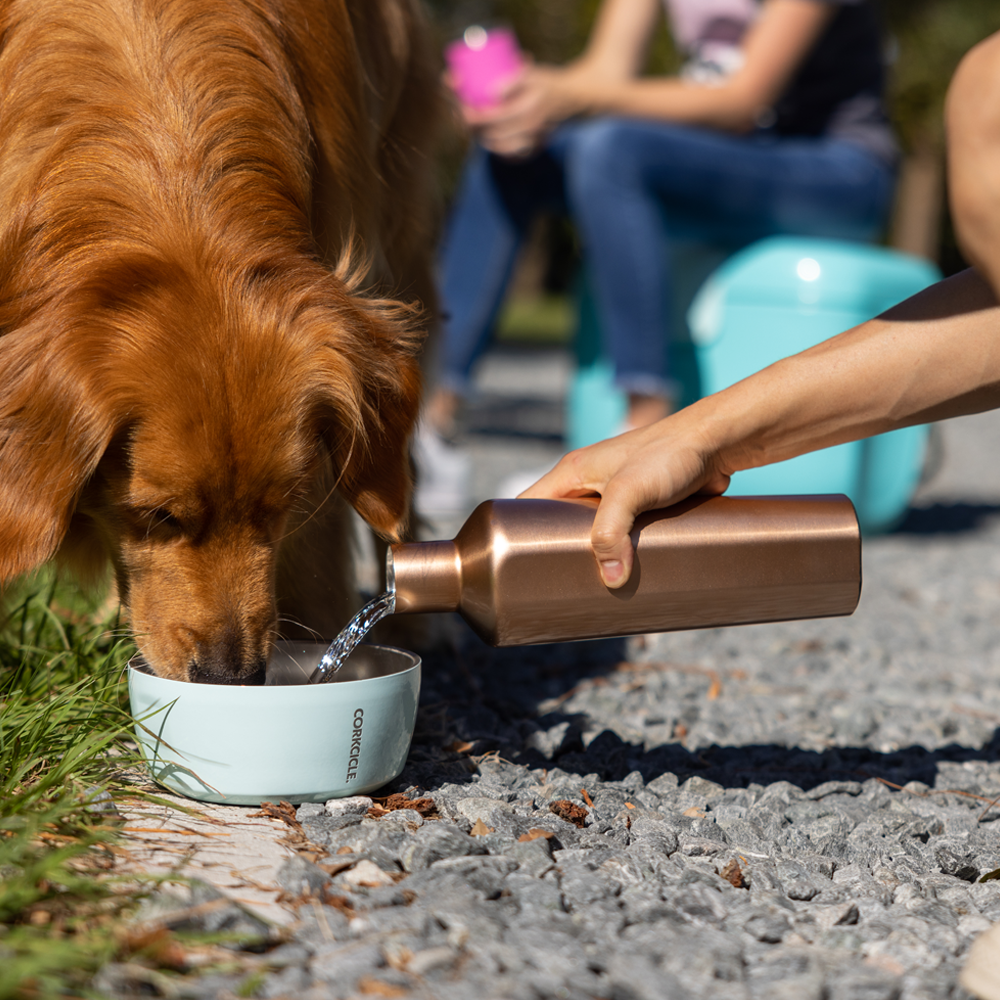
top-left (522, 270), bottom-right (1000, 587)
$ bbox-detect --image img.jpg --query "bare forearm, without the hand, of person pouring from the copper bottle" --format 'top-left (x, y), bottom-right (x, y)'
top-left (700, 271), bottom-right (1000, 475)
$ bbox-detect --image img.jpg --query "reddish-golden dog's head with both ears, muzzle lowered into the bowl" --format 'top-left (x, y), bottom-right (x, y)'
top-left (0, 254), bottom-right (419, 683)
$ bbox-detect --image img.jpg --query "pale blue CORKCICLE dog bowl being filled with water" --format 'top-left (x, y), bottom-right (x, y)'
top-left (128, 642), bottom-right (420, 805)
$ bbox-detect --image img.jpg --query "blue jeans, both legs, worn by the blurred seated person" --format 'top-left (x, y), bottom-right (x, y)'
top-left (439, 118), bottom-right (894, 395)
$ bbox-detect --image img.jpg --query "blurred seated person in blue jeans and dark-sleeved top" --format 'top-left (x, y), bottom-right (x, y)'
top-left (427, 0), bottom-right (895, 436)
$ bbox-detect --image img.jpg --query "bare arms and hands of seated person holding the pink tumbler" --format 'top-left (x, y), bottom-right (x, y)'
top-left (467, 0), bottom-right (834, 155)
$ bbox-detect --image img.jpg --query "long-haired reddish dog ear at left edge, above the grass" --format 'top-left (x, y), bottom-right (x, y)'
top-left (0, 323), bottom-right (112, 583)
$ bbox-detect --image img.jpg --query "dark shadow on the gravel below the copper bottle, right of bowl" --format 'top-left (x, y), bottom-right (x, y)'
top-left (398, 635), bottom-right (1000, 790)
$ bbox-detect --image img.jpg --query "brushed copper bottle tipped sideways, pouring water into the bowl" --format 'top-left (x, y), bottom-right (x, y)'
top-left (390, 496), bottom-right (861, 646)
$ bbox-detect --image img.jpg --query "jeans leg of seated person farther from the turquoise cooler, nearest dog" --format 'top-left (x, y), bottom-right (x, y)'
top-left (439, 141), bottom-right (565, 392)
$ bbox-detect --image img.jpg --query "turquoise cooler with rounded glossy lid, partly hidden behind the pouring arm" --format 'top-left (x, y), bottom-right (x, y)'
top-left (688, 237), bottom-right (940, 533)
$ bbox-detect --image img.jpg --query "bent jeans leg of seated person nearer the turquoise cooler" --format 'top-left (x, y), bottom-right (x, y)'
top-left (566, 118), bottom-right (893, 392)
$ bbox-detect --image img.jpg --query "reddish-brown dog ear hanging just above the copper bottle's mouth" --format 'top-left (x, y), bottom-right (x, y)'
top-left (308, 282), bottom-right (423, 541)
